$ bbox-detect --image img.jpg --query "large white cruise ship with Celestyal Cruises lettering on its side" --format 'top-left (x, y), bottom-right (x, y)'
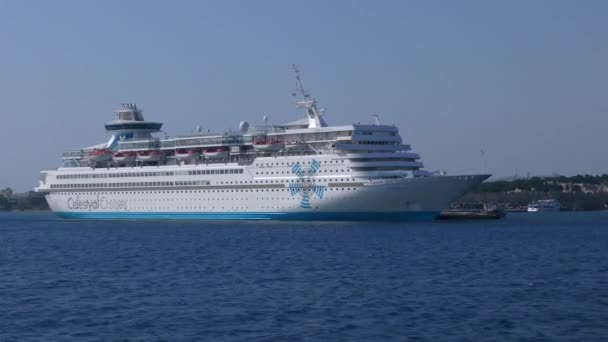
top-left (36, 66), bottom-right (489, 220)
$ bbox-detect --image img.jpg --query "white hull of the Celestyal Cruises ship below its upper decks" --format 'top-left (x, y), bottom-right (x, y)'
top-left (41, 163), bottom-right (487, 220)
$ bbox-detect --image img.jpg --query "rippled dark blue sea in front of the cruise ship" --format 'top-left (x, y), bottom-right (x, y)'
top-left (0, 212), bottom-right (608, 341)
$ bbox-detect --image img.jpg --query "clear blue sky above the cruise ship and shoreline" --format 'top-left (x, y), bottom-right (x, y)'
top-left (0, 0), bottom-right (608, 191)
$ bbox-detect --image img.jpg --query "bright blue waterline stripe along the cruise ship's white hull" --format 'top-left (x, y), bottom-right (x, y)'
top-left (55, 212), bottom-right (439, 221)
